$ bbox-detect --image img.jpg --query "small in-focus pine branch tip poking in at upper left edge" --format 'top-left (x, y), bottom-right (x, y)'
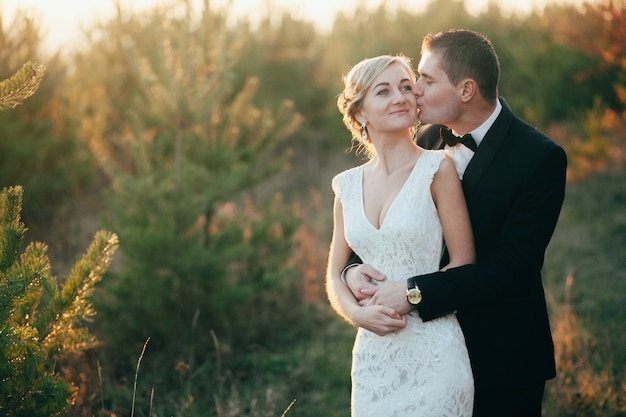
top-left (0, 61), bottom-right (45, 110)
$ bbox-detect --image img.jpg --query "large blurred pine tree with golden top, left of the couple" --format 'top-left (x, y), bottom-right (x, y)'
top-left (66, 1), bottom-right (305, 415)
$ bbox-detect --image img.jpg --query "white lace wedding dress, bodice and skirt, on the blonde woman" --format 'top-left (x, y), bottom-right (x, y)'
top-left (332, 151), bottom-right (474, 417)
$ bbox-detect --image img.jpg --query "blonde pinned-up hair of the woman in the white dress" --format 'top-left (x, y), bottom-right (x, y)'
top-left (337, 54), bottom-right (416, 157)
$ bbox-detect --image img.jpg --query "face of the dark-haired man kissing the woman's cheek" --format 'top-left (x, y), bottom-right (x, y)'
top-left (413, 50), bottom-right (462, 127)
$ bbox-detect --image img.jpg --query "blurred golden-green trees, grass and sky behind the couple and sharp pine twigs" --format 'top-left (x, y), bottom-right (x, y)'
top-left (0, 0), bottom-right (626, 417)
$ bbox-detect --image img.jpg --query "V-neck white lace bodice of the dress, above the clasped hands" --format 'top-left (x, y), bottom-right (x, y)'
top-left (333, 151), bottom-right (444, 281)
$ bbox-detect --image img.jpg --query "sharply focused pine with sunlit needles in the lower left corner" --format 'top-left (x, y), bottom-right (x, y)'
top-left (0, 186), bottom-right (117, 417)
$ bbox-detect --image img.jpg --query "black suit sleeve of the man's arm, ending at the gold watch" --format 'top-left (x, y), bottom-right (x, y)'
top-left (411, 146), bottom-right (567, 320)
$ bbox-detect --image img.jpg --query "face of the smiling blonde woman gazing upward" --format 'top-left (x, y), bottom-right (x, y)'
top-left (358, 63), bottom-right (417, 136)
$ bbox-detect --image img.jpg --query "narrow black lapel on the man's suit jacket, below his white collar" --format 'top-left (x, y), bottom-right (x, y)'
top-left (463, 98), bottom-right (514, 196)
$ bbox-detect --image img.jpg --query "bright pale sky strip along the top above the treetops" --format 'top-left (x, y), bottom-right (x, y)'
top-left (0, 0), bottom-right (576, 53)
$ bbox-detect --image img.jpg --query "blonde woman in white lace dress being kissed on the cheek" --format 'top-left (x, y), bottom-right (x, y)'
top-left (326, 55), bottom-right (475, 417)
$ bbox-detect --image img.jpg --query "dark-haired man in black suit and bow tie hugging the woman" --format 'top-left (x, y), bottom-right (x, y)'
top-left (333, 30), bottom-right (567, 417)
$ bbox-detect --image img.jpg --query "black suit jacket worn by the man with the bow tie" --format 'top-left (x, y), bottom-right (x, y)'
top-left (414, 99), bottom-right (567, 389)
